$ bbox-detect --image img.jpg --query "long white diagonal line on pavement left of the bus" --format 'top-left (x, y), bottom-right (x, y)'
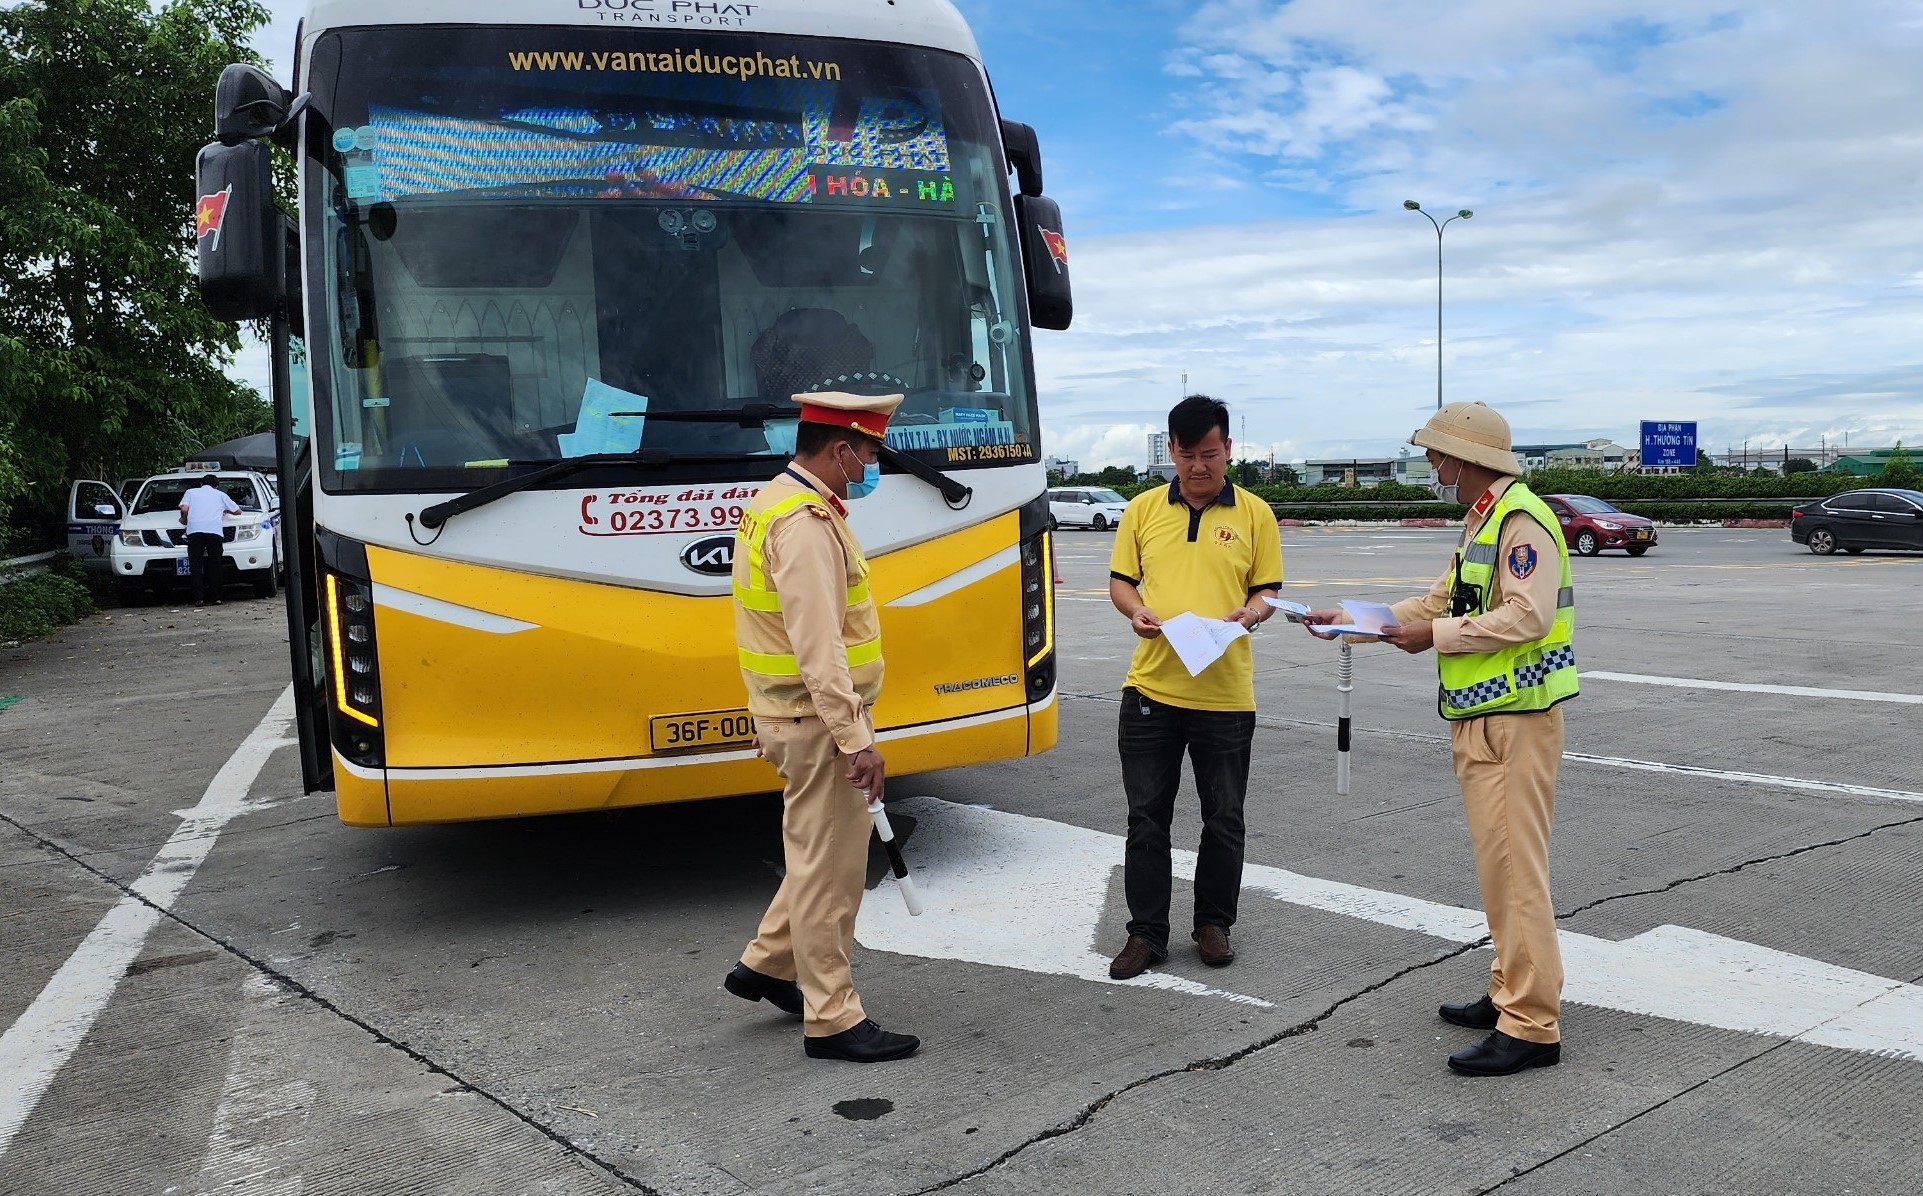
top-left (0, 686), bottom-right (294, 1156)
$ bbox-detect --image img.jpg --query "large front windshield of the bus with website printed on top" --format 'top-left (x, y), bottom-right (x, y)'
top-left (306, 27), bottom-right (1036, 492)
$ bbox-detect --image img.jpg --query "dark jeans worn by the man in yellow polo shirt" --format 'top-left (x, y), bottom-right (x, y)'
top-left (1115, 688), bottom-right (1256, 952)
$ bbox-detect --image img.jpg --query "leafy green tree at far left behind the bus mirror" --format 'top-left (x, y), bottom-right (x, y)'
top-left (0, 0), bottom-right (271, 542)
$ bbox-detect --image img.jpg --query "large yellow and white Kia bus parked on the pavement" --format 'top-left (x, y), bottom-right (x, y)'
top-left (198, 0), bottom-right (1071, 827)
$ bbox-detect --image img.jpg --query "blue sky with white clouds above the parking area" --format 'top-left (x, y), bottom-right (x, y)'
top-left (237, 0), bottom-right (1923, 469)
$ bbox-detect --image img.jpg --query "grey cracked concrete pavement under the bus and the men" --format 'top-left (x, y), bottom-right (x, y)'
top-left (0, 529), bottom-right (1923, 1196)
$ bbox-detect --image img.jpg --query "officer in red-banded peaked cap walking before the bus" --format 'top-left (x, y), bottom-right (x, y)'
top-left (723, 392), bottom-right (921, 1063)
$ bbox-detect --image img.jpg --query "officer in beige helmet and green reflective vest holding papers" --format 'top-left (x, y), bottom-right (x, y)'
top-left (1308, 402), bottom-right (1577, 1075)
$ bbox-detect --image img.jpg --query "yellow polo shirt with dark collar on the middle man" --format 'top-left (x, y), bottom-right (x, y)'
top-left (1108, 483), bottom-right (1283, 710)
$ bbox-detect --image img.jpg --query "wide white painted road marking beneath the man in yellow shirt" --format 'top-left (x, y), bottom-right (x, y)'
top-left (856, 798), bottom-right (1923, 1061)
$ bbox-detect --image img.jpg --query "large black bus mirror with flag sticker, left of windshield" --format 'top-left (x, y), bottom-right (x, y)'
top-left (194, 139), bottom-right (287, 321)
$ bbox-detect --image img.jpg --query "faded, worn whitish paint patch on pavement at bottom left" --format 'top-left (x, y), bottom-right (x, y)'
top-left (194, 973), bottom-right (313, 1196)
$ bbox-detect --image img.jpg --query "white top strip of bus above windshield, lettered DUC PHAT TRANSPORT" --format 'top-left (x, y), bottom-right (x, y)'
top-left (306, 0), bottom-right (981, 62)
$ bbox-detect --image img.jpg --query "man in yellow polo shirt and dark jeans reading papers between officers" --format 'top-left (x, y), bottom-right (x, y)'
top-left (1108, 394), bottom-right (1283, 981)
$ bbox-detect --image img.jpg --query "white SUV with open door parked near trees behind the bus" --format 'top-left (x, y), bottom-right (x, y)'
top-left (67, 469), bottom-right (285, 600)
